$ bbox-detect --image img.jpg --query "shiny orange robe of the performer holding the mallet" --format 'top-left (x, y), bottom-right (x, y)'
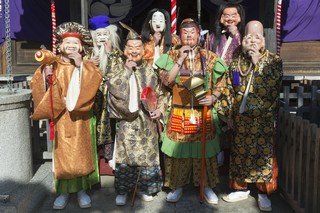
top-left (31, 59), bottom-right (102, 180)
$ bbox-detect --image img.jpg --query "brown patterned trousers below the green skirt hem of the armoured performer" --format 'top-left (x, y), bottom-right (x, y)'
top-left (164, 156), bottom-right (219, 190)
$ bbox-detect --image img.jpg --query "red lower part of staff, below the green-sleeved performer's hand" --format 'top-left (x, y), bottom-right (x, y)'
top-left (200, 106), bottom-right (208, 203)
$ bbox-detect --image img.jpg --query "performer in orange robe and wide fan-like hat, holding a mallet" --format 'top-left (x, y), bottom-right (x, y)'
top-left (31, 22), bottom-right (102, 209)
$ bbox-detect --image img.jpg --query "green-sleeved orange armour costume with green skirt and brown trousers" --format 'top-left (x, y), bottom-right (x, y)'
top-left (156, 48), bottom-right (225, 189)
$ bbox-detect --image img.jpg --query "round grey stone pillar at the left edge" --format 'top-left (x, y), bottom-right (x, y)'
top-left (0, 89), bottom-right (33, 189)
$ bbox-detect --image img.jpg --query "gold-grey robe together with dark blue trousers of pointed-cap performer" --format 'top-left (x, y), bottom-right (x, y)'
top-left (107, 51), bottom-right (167, 194)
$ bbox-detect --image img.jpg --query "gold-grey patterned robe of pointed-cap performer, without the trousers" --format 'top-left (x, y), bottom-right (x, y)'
top-left (107, 54), bottom-right (167, 167)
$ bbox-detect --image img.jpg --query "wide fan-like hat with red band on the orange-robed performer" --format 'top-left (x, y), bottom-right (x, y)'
top-left (53, 22), bottom-right (93, 55)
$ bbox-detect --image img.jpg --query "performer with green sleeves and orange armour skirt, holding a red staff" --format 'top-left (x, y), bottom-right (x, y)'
top-left (156, 18), bottom-right (225, 204)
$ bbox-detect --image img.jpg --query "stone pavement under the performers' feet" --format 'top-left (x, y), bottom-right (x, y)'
top-left (0, 162), bottom-right (294, 213)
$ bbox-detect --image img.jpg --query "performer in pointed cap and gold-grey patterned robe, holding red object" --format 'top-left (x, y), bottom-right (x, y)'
top-left (107, 24), bottom-right (167, 205)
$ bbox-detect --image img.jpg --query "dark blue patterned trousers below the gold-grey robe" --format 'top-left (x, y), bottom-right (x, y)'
top-left (115, 164), bottom-right (162, 195)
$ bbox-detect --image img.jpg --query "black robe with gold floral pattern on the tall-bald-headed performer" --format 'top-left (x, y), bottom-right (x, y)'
top-left (224, 51), bottom-right (282, 183)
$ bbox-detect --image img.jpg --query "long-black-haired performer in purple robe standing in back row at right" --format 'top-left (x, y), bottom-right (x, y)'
top-left (209, 0), bottom-right (245, 170)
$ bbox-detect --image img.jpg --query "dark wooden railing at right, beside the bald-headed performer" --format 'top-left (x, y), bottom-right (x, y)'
top-left (277, 87), bottom-right (320, 213)
